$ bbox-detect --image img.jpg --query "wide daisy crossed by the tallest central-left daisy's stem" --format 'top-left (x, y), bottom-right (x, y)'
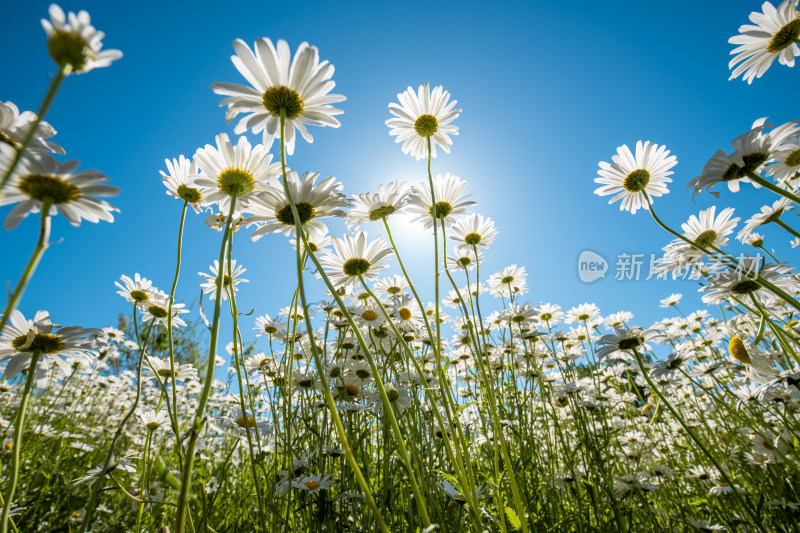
top-left (247, 170), bottom-right (348, 241)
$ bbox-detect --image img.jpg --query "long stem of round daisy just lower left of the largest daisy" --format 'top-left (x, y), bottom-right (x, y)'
top-left (175, 194), bottom-right (236, 533)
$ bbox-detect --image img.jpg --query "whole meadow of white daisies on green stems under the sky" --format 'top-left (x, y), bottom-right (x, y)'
top-left (0, 0), bottom-right (800, 533)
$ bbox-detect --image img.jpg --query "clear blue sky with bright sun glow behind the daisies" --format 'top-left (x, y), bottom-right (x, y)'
top-left (0, 1), bottom-right (798, 345)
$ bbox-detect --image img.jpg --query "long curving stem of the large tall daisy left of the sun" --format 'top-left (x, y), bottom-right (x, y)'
top-left (278, 108), bottom-right (389, 533)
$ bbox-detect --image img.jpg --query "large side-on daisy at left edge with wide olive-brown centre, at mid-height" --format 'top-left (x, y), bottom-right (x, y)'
top-left (0, 153), bottom-right (119, 230)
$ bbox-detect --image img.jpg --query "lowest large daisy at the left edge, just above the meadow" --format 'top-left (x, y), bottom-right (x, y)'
top-left (0, 309), bottom-right (100, 379)
